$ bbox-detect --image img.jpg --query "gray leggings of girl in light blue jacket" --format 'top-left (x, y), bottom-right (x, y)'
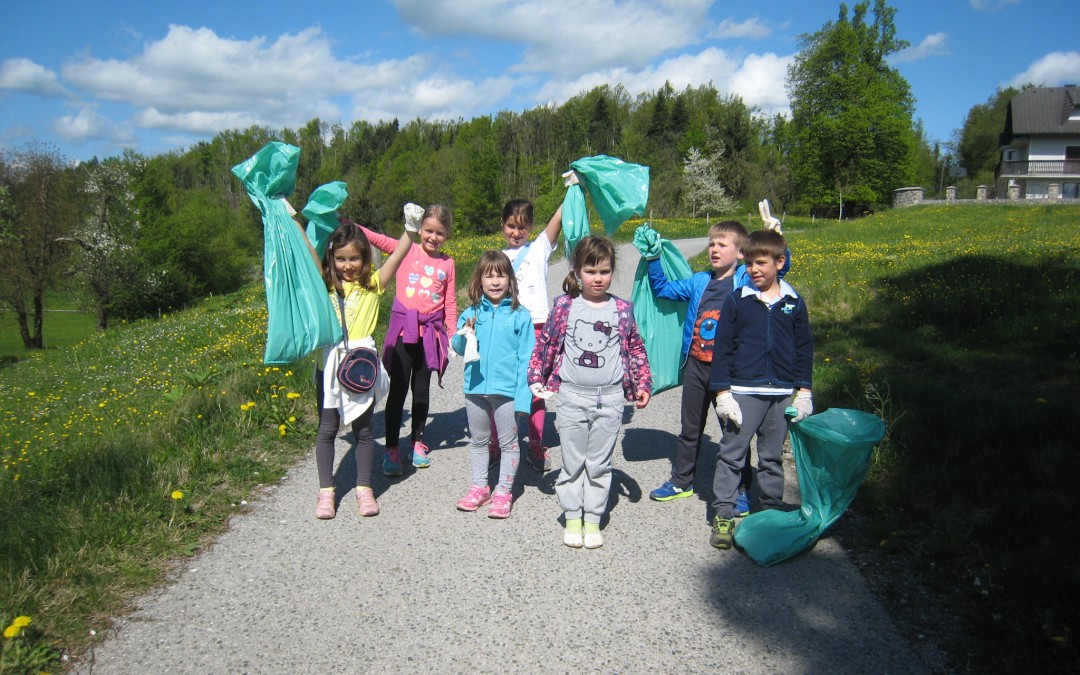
top-left (465, 394), bottom-right (521, 492)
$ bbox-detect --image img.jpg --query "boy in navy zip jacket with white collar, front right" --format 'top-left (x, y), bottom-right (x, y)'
top-left (708, 230), bottom-right (813, 549)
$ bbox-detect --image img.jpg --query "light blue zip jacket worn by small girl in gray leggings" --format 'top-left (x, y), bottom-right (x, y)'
top-left (450, 297), bottom-right (536, 413)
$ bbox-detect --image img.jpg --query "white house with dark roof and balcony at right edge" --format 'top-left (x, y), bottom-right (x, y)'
top-left (997, 84), bottom-right (1080, 199)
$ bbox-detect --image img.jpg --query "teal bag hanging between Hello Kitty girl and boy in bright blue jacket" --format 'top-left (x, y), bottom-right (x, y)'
top-left (631, 222), bottom-right (693, 394)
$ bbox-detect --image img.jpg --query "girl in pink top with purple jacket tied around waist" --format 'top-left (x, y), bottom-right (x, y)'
top-left (373, 204), bottom-right (458, 476)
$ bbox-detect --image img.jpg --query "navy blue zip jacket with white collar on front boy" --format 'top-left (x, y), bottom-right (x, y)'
top-left (708, 281), bottom-right (813, 391)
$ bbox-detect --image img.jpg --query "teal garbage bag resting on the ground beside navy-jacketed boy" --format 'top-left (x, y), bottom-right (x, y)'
top-left (734, 408), bottom-right (885, 567)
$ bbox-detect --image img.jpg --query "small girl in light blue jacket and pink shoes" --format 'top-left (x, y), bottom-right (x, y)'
top-left (450, 251), bottom-right (536, 518)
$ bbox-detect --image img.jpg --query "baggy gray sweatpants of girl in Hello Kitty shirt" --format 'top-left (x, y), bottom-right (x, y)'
top-left (555, 382), bottom-right (625, 523)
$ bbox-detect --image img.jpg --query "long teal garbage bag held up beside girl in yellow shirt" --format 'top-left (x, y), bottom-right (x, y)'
top-left (232, 141), bottom-right (341, 364)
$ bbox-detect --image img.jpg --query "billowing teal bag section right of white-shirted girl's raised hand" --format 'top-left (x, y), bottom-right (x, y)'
top-left (564, 154), bottom-right (649, 235)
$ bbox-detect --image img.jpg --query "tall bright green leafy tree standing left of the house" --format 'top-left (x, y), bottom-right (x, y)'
top-left (787, 0), bottom-right (915, 203)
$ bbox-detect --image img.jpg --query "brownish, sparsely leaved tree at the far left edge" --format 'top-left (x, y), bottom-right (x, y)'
top-left (0, 145), bottom-right (78, 349)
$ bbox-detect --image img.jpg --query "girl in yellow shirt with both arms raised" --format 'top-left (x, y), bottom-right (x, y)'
top-left (297, 222), bottom-right (413, 521)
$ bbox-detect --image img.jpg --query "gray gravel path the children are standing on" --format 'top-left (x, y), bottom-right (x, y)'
top-left (76, 240), bottom-right (928, 673)
